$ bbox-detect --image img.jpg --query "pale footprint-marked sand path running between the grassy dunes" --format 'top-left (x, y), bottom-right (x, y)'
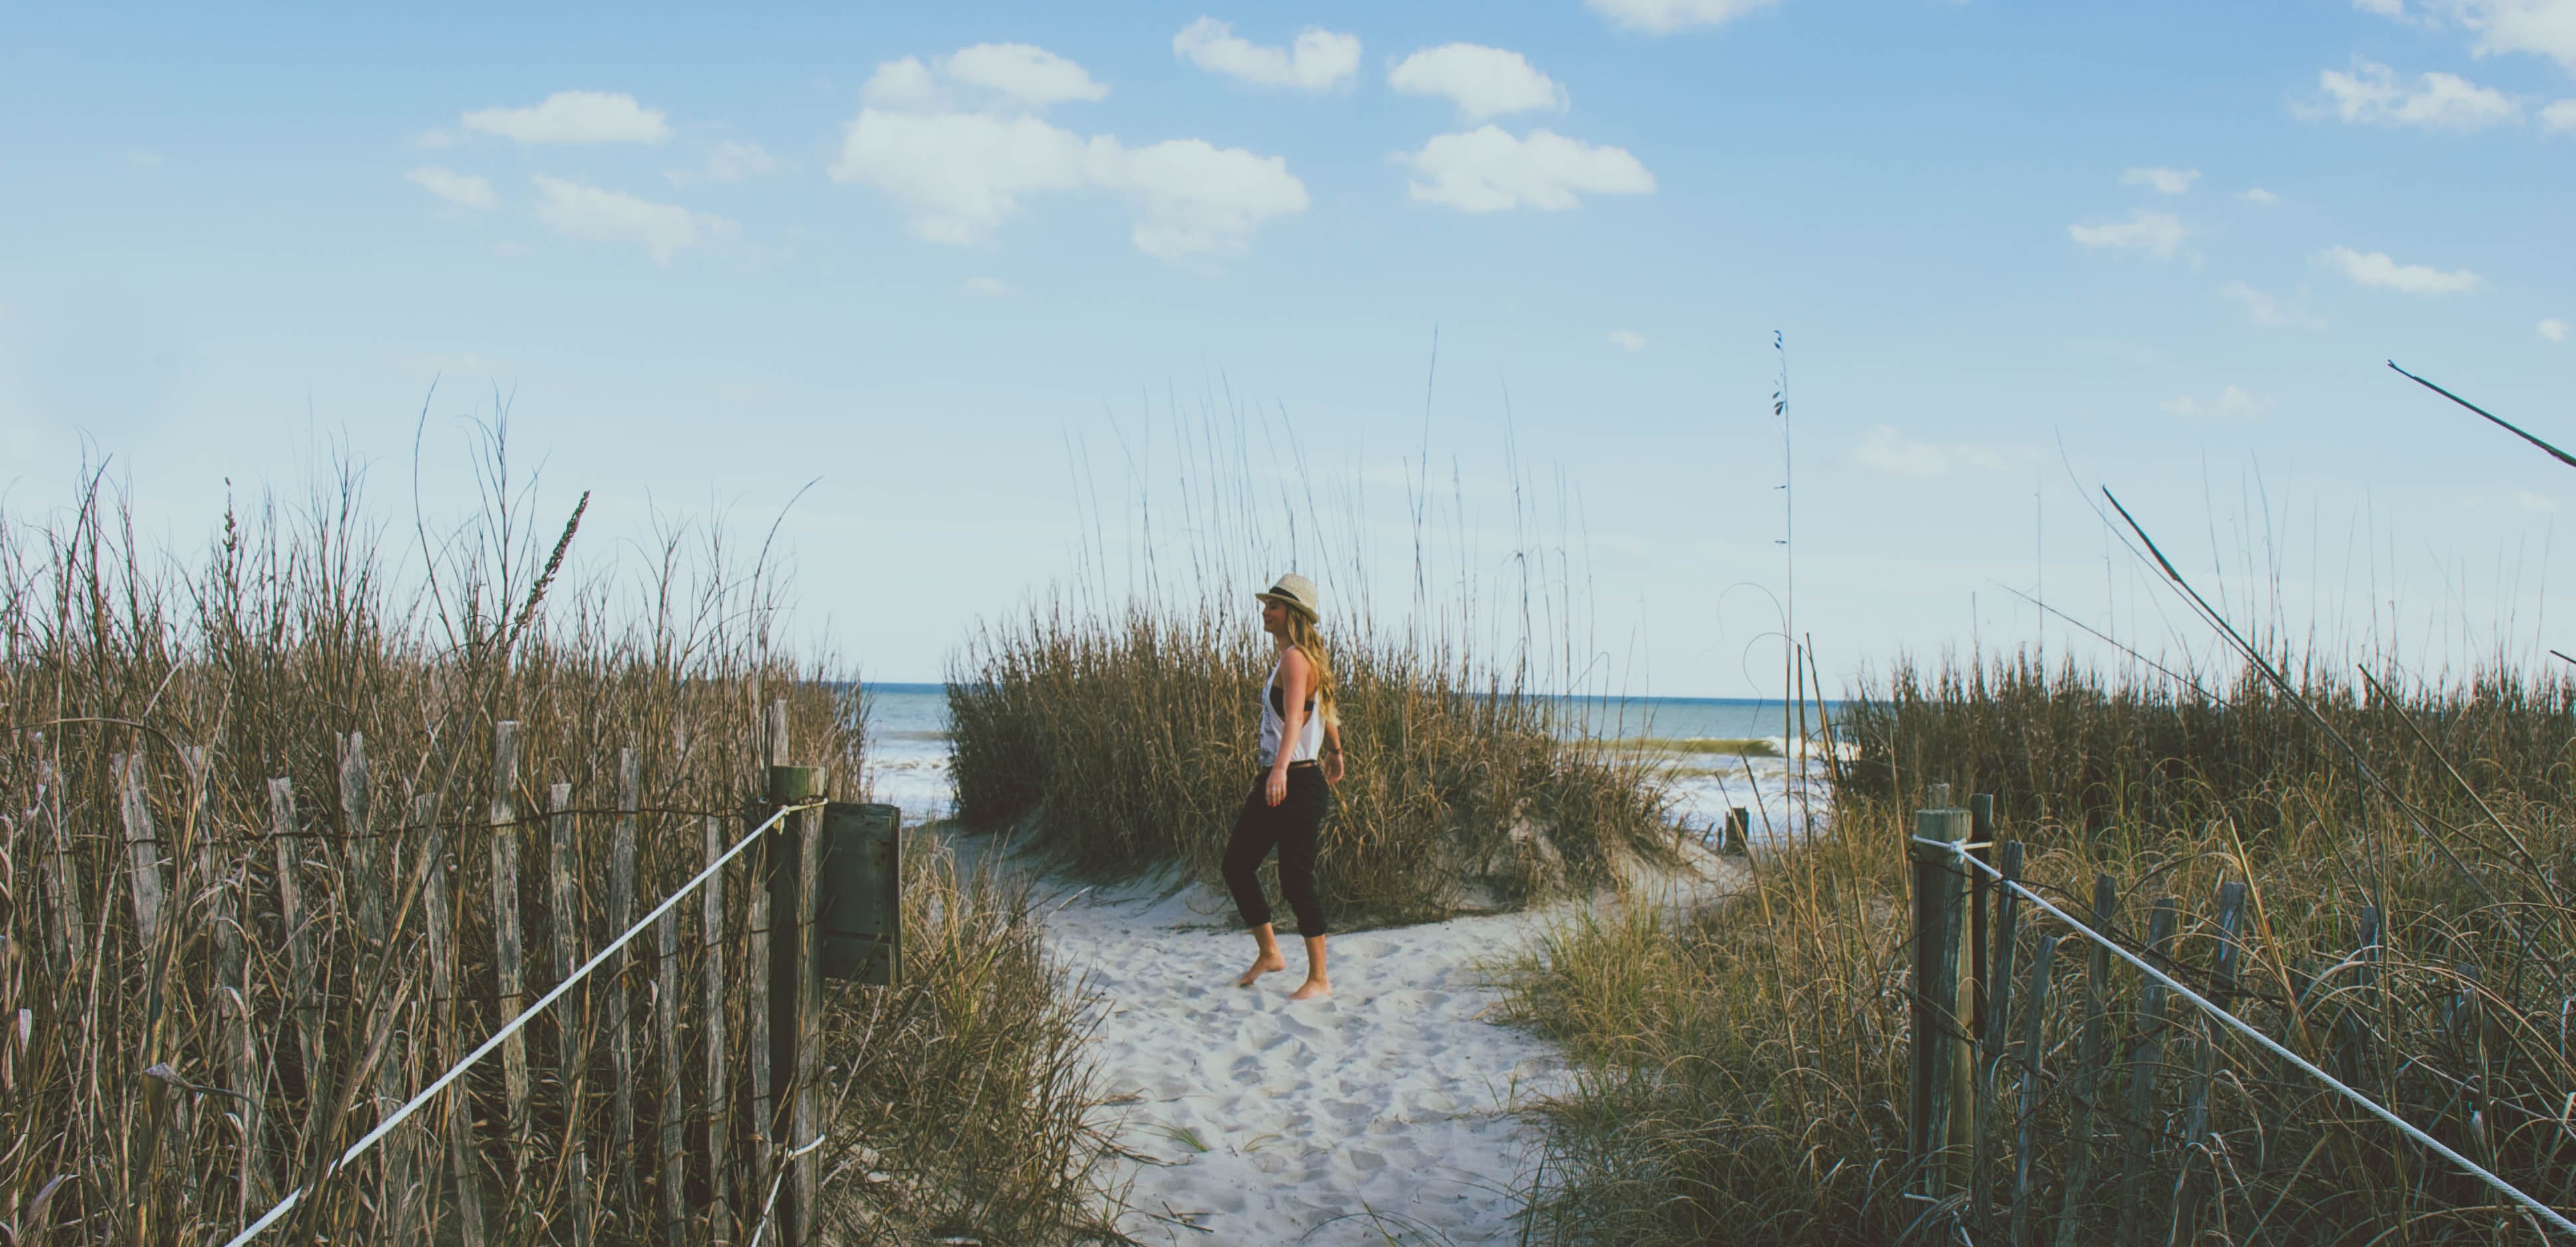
top-left (951, 834), bottom-right (1739, 1247)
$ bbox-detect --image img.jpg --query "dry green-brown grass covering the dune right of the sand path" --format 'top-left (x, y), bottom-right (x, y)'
top-left (1515, 659), bottom-right (2576, 1244)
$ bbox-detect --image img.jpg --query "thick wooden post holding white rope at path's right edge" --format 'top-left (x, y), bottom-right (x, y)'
top-left (1906, 783), bottom-right (1968, 1198)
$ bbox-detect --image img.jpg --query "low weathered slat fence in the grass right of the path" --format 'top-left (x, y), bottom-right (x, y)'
top-left (1906, 783), bottom-right (2558, 1247)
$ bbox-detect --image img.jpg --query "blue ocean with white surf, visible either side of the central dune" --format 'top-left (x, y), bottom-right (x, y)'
top-left (860, 683), bottom-right (1842, 840)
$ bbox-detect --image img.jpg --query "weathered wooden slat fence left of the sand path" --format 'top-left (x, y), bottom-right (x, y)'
top-left (15, 701), bottom-right (860, 1247)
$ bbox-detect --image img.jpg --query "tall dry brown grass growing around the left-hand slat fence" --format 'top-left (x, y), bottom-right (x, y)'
top-left (0, 453), bottom-right (1092, 1244)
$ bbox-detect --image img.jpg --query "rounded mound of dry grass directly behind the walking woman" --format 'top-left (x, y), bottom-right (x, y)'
top-left (948, 590), bottom-right (1669, 925)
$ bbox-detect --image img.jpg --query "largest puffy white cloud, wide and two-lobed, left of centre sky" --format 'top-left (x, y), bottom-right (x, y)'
top-left (832, 108), bottom-right (1306, 258)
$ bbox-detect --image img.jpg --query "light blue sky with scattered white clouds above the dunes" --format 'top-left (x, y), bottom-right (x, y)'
top-left (0, 0), bottom-right (2576, 695)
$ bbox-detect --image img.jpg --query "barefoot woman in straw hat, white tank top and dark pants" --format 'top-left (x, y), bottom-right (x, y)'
top-left (1226, 572), bottom-right (1342, 999)
